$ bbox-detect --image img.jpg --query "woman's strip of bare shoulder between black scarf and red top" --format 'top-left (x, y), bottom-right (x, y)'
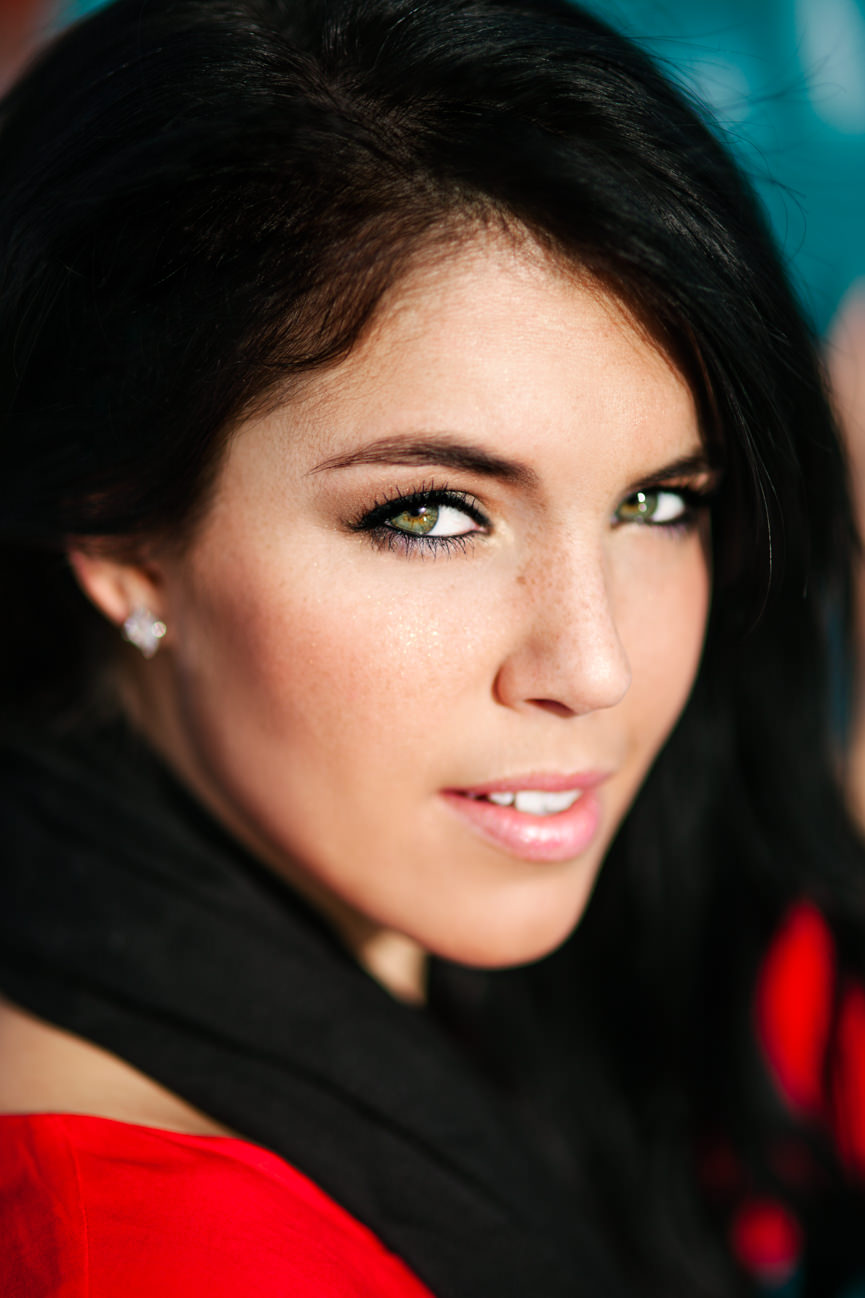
top-left (0, 998), bottom-right (232, 1136)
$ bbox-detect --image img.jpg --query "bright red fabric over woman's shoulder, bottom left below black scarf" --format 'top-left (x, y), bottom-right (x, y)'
top-left (0, 1115), bottom-right (431, 1298)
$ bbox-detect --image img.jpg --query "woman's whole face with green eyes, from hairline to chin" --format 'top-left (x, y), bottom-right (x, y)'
top-left (126, 240), bottom-right (710, 981)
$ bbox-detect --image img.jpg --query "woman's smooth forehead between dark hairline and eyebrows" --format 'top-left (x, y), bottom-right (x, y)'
top-left (222, 228), bottom-right (700, 490)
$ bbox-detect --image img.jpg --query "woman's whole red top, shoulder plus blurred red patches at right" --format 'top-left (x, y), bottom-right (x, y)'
top-left (0, 902), bottom-right (865, 1298)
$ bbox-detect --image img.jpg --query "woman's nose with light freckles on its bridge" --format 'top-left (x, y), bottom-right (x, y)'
top-left (494, 542), bottom-right (631, 716)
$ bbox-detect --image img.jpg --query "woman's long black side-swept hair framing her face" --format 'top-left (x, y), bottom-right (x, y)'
top-left (0, 0), bottom-right (865, 1293)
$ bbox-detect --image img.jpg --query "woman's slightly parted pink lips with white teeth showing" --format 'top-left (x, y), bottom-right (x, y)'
top-left (442, 771), bottom-right (607, 861)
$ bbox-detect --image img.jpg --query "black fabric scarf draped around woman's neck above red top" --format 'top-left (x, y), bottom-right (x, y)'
top-left (0, 726), bottom-right (620, 1298)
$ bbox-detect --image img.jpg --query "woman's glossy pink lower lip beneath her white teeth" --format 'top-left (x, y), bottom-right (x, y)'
top-left (442, 789), bottom-right (600, 861)
